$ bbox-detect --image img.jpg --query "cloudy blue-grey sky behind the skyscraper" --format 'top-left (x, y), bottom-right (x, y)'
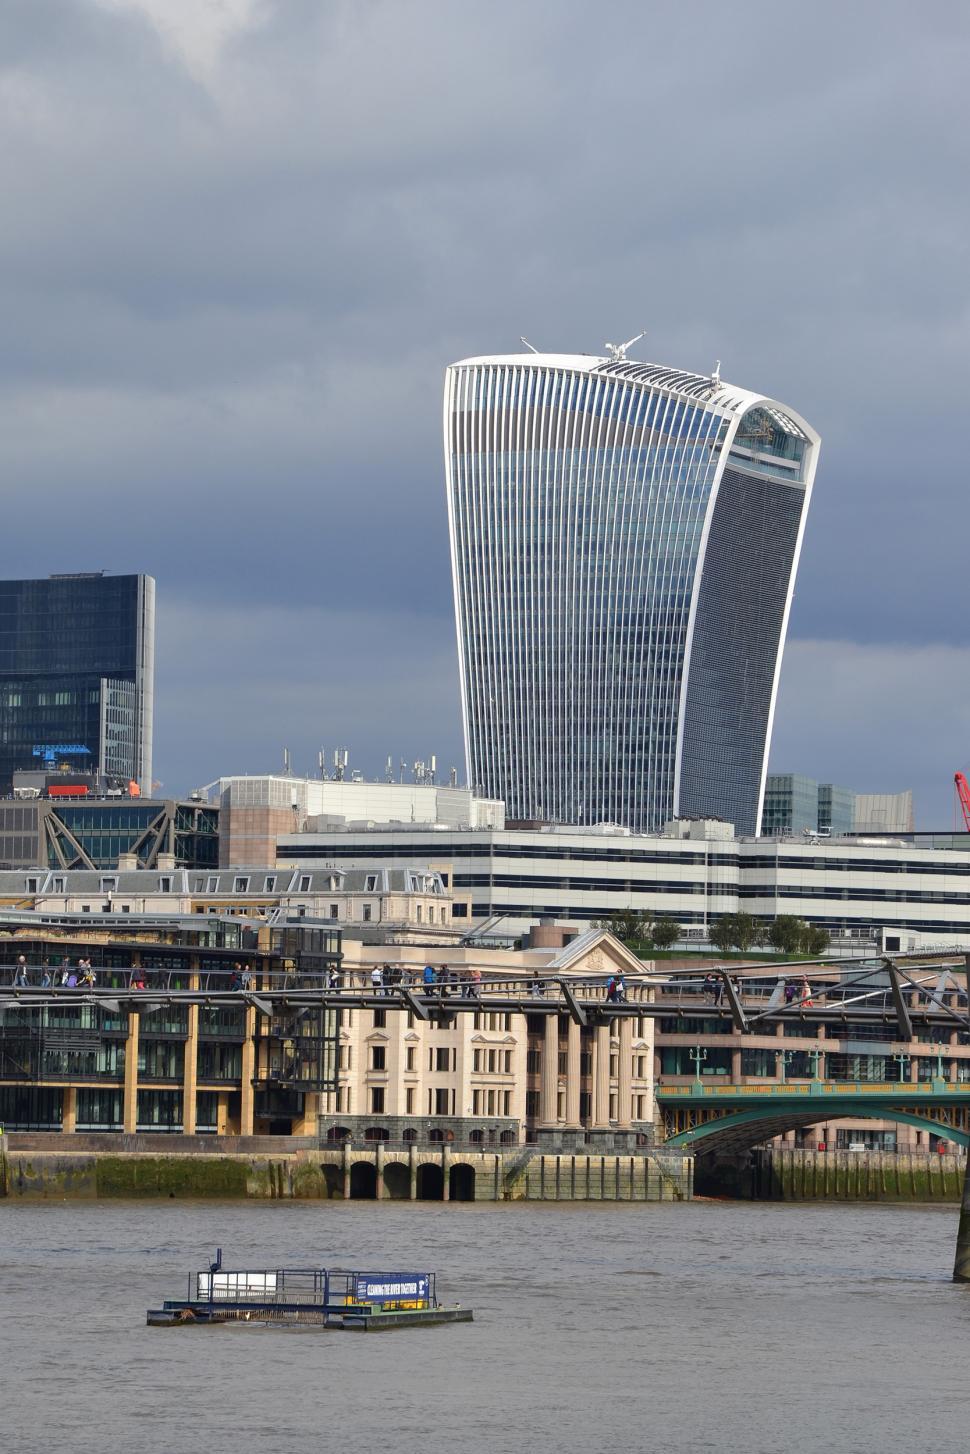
top-left (0, 0), bottom-right (970, 827)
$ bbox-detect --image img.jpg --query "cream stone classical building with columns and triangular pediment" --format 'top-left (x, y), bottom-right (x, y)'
top-left (330, 926), bottom-right (654, 1146)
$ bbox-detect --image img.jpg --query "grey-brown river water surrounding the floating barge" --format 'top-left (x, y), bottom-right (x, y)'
top-left (0, 1201), bottom-right (970, 1454)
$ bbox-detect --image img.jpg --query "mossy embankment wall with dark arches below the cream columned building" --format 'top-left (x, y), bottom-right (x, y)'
top-left (0, 1133), bottom-right (692, 1201)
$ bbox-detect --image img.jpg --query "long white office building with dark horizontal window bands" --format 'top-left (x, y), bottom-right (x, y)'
top-left (279, 820), bottom-right (970, 949)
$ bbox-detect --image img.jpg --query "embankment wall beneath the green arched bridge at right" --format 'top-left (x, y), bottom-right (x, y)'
top-left (753, 1147), bottom-right (967, 1202)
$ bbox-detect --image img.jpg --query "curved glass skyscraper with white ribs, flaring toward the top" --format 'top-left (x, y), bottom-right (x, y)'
top-left (445, 350), bottom-right (819, 833)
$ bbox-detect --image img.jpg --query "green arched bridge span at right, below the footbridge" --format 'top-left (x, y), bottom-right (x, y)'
top-left (657, 1079), bottom-right (970, 1153)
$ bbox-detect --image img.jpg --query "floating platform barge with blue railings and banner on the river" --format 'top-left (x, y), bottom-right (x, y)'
top-left (148, 1248), bottom-right (473, 1333)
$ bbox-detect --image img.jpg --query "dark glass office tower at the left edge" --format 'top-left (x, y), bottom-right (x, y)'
top-left (0, 573), bottom-right (156, 794)
